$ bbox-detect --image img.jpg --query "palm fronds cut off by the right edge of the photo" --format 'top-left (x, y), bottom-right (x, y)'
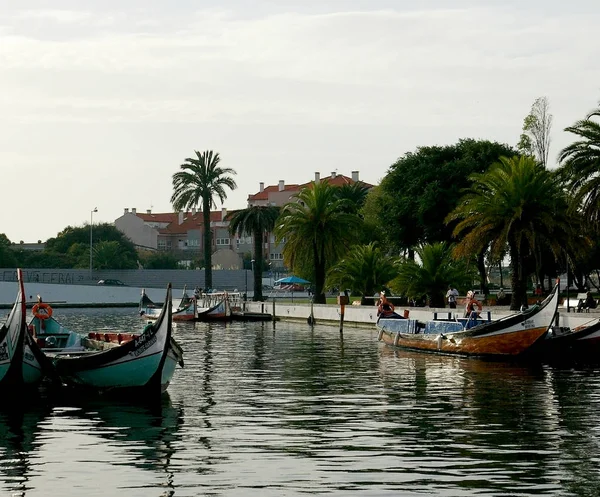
top-left (558, 107), bottom-right (600, 229)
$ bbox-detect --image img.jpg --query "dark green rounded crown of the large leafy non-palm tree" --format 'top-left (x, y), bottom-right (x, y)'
top-left (378, 140), bottom-right (513, 252)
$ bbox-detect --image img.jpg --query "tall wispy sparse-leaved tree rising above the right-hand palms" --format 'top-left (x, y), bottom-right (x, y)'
top-left (517, 97), bottom-right (552, 167)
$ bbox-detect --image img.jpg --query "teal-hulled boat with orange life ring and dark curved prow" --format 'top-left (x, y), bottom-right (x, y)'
top-left (28, 284), bottom-right (183, 397)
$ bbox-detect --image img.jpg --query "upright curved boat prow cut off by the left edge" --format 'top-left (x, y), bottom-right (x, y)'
top-left (0, 269), bottom-right (27, 390)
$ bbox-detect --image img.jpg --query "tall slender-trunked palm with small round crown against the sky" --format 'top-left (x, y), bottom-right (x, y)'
top-left (171, 150), bottom-right (237, 288)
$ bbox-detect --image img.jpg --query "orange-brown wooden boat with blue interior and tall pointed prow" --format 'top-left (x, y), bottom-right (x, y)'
top-left (376, 283), bottom-right (558, 358)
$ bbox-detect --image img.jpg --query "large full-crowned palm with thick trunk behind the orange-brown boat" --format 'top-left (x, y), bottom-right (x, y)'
top-left (446, 156), bottom-right (575, 310)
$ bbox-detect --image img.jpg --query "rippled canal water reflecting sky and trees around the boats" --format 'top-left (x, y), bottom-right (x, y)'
top-left (0, 309), bottom-right (600, 497)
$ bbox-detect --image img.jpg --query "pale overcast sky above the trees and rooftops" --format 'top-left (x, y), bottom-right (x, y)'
top-left (0, 0), bottom-right (600, 243)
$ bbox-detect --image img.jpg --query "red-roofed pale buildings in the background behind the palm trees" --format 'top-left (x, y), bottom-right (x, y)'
top-left (115, 171), bottom-right (372, 271)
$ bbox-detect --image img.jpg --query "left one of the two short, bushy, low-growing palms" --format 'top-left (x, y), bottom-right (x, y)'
top-left (327, 242), bottom-right (398, 305)
